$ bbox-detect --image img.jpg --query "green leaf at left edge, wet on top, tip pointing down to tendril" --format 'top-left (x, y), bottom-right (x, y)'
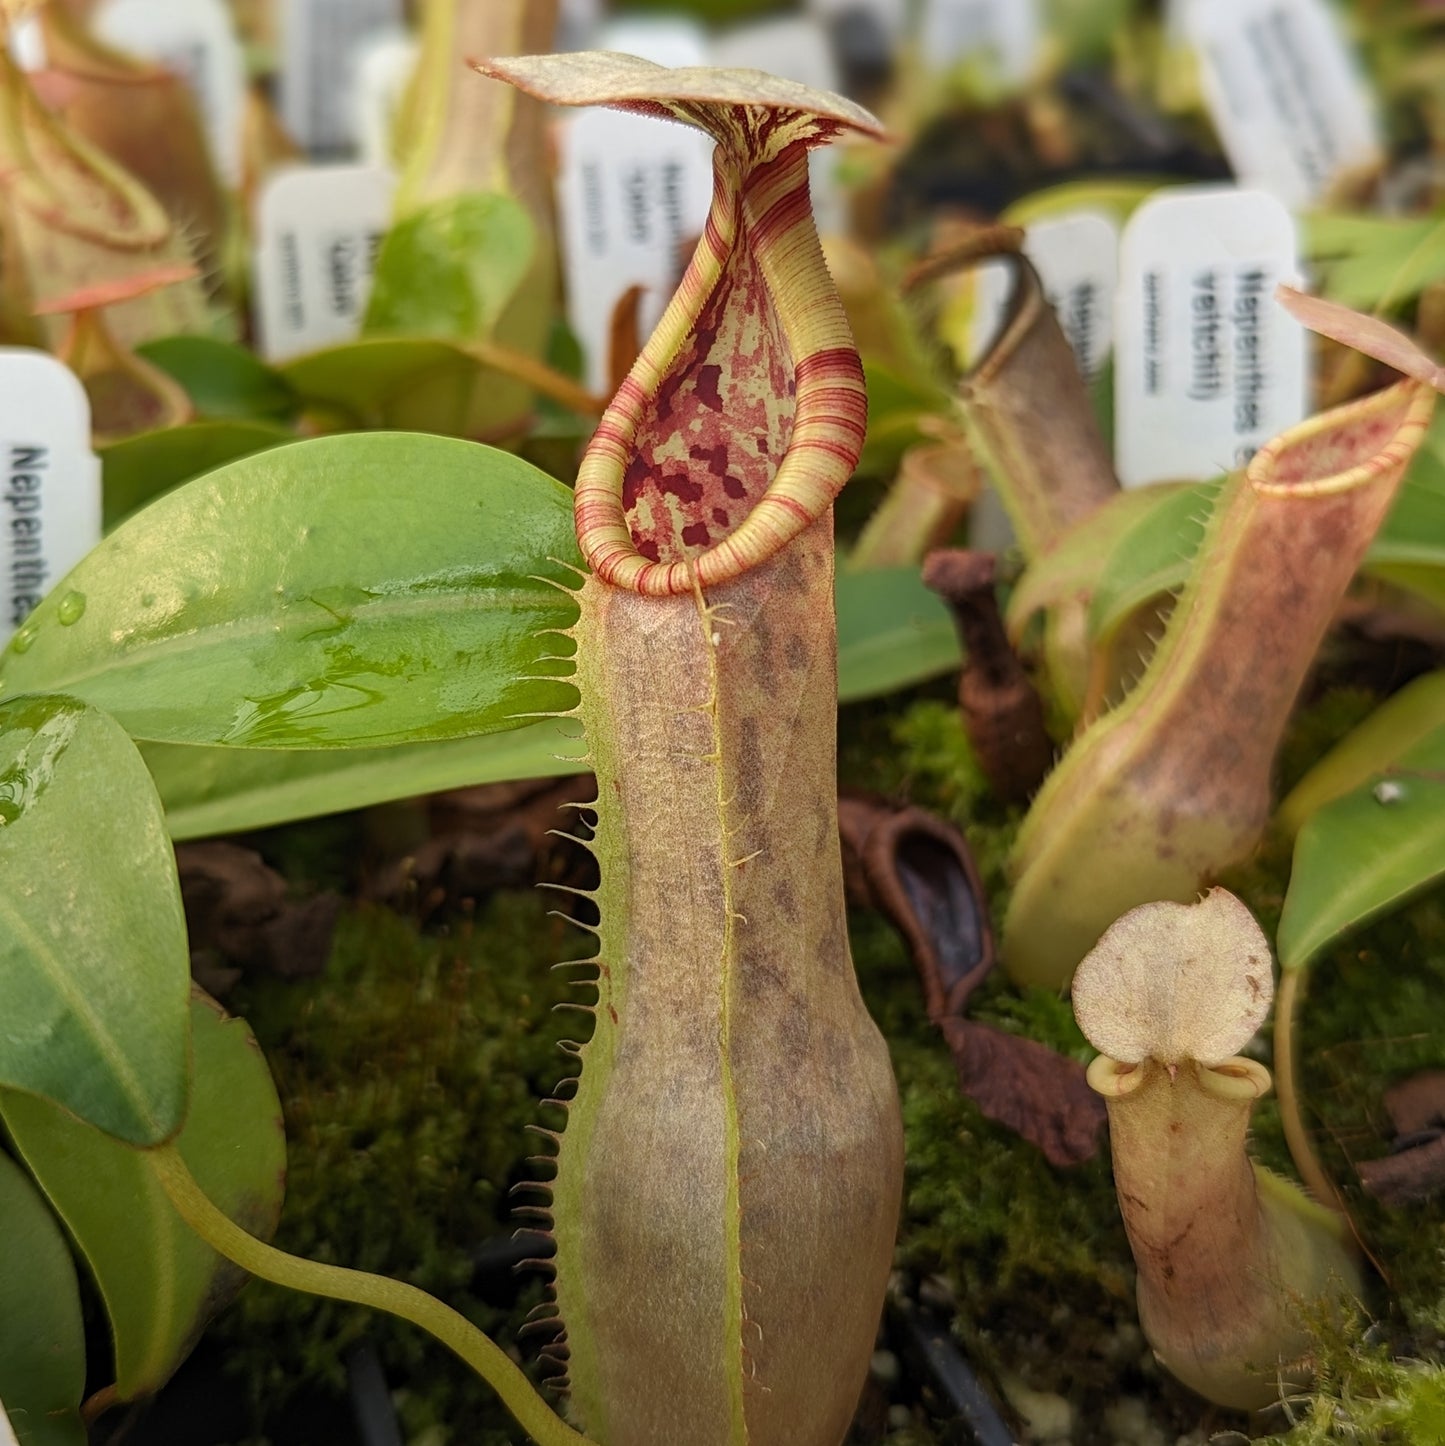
top-left (0, 697), bottom-right (191, 1145)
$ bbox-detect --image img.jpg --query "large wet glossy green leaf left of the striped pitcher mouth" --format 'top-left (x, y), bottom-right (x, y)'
top-left (0, 434), bottom-right (577, 748)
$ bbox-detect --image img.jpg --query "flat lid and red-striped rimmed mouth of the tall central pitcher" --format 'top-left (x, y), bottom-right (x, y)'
top-left (482, 56), bottom-right (878, 597)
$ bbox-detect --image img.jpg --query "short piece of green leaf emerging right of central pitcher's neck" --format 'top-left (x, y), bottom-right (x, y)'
top-left (835, 567), bottom-right (959, 703)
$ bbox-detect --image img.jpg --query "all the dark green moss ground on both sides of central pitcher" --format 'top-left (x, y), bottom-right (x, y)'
top-left (206, 690), bottom-right (1445, 1446)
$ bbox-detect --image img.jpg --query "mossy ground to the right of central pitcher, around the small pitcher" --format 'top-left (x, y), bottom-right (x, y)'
top-left (843, 690), bottom-right (1445, 1446)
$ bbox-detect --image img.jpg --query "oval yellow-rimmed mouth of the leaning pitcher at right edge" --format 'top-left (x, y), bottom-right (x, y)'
top-left (1245, 379), bottom-right (1435, 497)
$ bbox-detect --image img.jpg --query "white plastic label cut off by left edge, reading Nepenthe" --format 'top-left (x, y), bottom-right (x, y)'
top-left (0, 347), bottom-right (100, 644)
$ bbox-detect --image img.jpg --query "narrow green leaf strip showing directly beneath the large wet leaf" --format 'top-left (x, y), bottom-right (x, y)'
top-left (140, 720), bottom-right (587, 840)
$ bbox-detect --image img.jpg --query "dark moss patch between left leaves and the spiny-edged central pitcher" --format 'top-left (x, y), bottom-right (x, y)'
top-left (216, 892), bottom-right (587, 1446)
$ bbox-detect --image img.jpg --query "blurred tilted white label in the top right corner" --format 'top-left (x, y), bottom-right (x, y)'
top-left (1185, 0), bottom-right (1384, 210)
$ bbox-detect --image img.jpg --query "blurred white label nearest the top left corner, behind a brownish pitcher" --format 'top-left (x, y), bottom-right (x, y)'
top-left (94, 0), bottom-right (246, 187)
